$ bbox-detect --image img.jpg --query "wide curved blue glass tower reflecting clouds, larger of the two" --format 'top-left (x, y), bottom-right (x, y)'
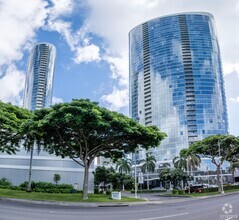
top-left (129, 13), bottom-right (228, 161)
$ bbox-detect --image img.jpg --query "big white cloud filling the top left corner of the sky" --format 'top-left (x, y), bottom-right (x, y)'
top-left (0, 0), bottom-right (47, 65)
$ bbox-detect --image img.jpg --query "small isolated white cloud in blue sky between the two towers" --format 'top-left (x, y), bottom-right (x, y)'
top-left (74, 44), bottom-right (101, 64)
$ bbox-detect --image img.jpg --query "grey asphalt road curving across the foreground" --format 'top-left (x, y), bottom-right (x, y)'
top-left (0, 194), bottom-right (239, 220)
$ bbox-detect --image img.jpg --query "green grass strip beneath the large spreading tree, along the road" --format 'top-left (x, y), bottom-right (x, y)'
top-left (0, 189), bottom-right (144, 202)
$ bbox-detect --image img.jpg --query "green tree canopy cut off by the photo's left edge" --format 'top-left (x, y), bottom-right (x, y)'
top-left (0, 101), bottom-right (32, 154)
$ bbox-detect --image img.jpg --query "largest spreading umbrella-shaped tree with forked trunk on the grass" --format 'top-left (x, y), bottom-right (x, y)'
top-left (30, 99), bottom-right (165, 199)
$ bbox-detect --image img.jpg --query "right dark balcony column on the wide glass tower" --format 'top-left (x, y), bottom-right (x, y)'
top-left (178, 15), bottom-right (197, 144)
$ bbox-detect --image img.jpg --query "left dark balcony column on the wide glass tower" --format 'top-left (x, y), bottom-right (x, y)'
top-left (142, 22), bottom-right (152, 125)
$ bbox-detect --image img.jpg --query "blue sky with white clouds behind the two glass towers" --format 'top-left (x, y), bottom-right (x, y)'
top-left (0, 0), bottom-right (239, 135)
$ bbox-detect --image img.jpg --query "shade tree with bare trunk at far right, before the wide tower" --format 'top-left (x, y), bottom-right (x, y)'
top-left (187, 135), bottom-right (239, 192)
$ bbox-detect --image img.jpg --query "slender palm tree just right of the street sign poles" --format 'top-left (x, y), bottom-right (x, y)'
top-left (140, 153), bottom-right (156, 190)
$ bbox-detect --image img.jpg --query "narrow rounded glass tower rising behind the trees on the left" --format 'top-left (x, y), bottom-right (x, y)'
top-left (23, 43), bottom-right (56, 110)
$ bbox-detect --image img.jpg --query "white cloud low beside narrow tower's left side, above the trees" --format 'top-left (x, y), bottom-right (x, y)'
top-left (0, 65), bottom-right (25, 106)
